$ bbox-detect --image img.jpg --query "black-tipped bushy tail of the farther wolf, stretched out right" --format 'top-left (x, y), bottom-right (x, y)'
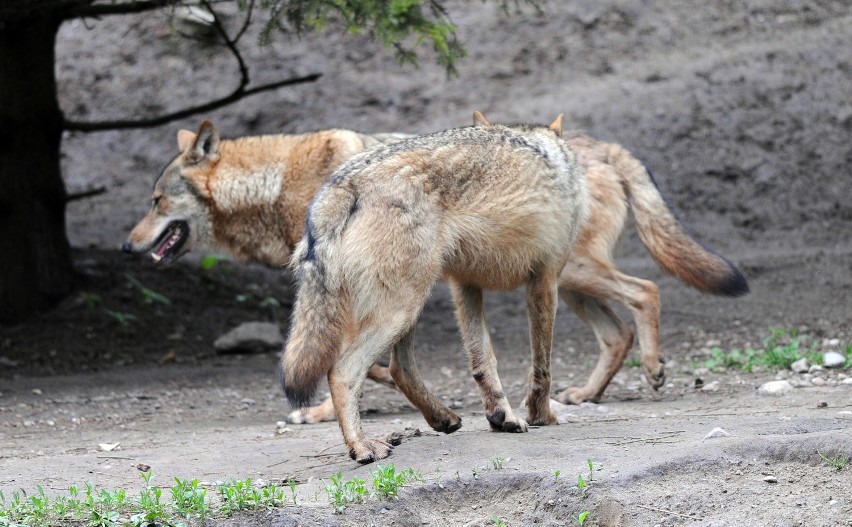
top-left (608, 145), bottom-right (749, 296)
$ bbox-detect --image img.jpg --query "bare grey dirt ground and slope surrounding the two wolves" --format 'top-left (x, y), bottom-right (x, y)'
top-left (0, 0), bottom-right (852, 526)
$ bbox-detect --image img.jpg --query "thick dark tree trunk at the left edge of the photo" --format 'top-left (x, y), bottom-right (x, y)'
top-left (0, 18), bottom-right (74, 322)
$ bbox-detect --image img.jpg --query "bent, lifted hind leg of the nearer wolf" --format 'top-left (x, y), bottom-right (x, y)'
top-left (390, 327), bottom-right (461, 434)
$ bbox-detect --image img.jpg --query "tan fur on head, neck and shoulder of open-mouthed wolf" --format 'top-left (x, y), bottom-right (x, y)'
top-left (125, 121), bottom-right (376, 267)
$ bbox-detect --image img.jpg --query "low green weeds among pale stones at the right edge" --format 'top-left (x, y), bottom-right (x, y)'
top-left (703, 326), bottom-right (852, 372)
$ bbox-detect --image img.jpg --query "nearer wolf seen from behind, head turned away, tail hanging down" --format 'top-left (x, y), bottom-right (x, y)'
top-left (281, 115), bottom-right (587, 463)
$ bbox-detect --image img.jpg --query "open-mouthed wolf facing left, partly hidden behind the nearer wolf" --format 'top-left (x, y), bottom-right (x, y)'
top-left (124, 114), bottom-right (748, 422)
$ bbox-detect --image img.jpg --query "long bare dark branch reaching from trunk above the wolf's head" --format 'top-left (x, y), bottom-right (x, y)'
top-left (64, 73), bottom-right (322, 133)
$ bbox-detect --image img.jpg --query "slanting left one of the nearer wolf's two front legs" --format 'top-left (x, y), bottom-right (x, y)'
top-left (450, 282), bottom-right (527, 432)
